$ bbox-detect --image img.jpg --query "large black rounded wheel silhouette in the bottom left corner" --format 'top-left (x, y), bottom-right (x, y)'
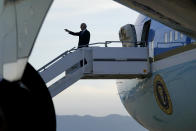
top-left (0, 64), bottom-right (56, 131)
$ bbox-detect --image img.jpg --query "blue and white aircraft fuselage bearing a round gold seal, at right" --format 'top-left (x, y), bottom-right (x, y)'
top-left (117, 15), bottom-right (196, 131)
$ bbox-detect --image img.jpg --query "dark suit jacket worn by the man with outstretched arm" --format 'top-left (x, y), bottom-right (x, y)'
top-left (69, 30), bottom-right (90, 48)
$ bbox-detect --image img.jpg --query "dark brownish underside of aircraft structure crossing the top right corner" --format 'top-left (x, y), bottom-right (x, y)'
top-left (114, 0), bottom-right (196, 38)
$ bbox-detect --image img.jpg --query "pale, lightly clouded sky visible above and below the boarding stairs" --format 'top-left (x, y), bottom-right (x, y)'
top-left (29, 0), bottom-right (138, 116)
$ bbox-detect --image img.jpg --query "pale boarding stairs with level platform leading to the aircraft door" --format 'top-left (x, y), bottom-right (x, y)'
top-left (38, 47), bottom-right (150, 97)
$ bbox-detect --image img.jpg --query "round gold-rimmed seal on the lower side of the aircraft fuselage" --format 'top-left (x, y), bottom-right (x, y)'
top-left (153, 74), bottom-right (173, 115)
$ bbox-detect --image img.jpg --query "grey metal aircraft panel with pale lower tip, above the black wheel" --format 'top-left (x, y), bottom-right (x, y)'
top-left (0, 0), bottom-right (53, 81)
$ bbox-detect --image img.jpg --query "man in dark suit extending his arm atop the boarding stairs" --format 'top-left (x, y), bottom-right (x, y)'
top-left (65, 23), bottom-right (90, 48)
